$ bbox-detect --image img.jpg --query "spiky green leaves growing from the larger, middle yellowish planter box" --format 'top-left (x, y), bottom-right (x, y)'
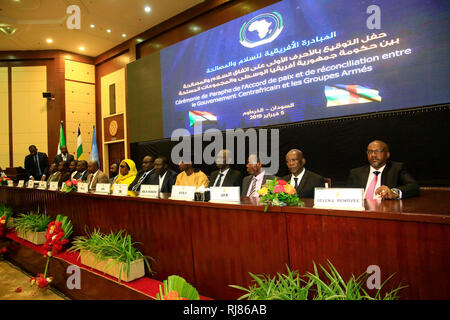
top-left (70, 229), bottom-right (153, 283)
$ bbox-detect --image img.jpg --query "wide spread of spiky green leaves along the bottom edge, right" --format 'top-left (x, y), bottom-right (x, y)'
top-left (230, 261), bottom-right (406, 300)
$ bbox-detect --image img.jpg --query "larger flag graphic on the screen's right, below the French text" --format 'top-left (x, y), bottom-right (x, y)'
top-left (325, 84), bottom-right (381, 107)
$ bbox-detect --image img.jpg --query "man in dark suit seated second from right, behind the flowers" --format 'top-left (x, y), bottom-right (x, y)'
top-left (281, 149), bottom-right (325, 198)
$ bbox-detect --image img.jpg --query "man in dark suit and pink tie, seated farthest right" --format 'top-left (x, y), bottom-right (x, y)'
top-left (347, 140), bottom-right (419, 200)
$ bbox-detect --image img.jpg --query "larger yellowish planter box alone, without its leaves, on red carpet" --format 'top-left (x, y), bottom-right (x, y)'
top-left (80, 250), bottom-right (145, 282)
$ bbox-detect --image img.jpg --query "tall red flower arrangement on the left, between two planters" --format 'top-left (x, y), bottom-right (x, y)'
top-left (30, 215), bottom-right (72, 290)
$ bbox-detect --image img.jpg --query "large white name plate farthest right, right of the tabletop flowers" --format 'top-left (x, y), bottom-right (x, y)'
top-left (314, 188), bottom-right (365, 211)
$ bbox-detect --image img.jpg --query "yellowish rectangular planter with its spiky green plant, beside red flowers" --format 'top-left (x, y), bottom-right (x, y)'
top-left (70, 229), bottom-right (152, 283)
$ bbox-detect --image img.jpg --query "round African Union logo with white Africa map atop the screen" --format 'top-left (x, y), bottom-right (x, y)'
top-left (239, 11), bottom-right (283, 48)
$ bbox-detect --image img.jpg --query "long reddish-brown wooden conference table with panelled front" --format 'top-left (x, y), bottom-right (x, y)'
top-left (0, 187), bottom-right (450, 299)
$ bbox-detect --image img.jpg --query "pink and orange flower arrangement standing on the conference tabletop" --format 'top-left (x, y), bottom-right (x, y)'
top-left (258, 179), bottom-right (304, 212)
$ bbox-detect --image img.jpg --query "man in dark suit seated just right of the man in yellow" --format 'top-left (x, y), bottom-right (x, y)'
top-left (209, 150), bottom-right (242, 187)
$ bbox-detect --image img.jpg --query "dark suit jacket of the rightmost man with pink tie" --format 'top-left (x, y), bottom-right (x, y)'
top-left (347, 161), bottom-right (419, 198)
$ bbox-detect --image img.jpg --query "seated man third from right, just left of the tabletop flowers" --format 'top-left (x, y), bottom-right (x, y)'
top-left (241, 154), bottom-right (276, 197)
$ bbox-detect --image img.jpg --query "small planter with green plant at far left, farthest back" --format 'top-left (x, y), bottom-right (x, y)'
top-left (14, 212), bottom-right (51, 245)
